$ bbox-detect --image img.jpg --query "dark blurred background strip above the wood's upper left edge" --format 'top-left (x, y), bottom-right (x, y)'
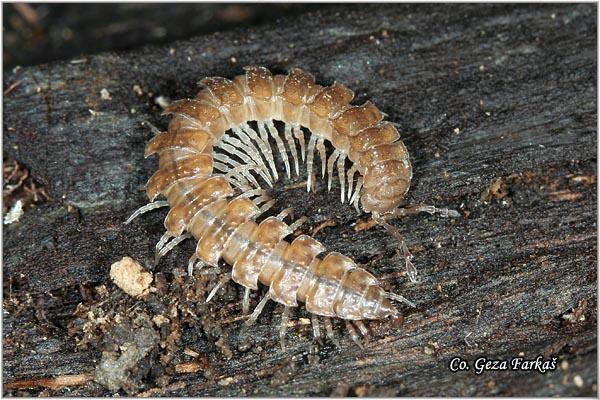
top-left (2, 3), bottom-right (318, 68)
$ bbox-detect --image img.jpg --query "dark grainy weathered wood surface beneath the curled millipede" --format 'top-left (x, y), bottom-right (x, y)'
top-left (3, 4), bottom-right (597, 396)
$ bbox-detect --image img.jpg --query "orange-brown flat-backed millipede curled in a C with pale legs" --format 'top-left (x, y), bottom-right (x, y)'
top-left (128, 66), bottom-right (457, 346)
